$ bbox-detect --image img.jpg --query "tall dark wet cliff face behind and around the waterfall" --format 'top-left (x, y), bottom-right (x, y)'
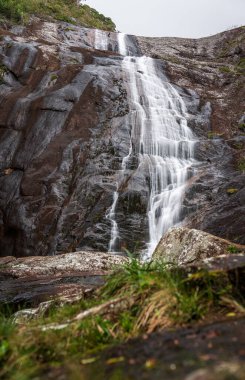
top-left (0, 19), bottom-right (245, 257)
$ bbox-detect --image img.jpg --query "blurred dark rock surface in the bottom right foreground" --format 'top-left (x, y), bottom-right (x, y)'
top-left (83, 318), bottom-right (245, 380)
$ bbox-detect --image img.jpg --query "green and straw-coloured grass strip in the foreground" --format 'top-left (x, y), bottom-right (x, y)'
top-left (0, 260), bottom-right (244, 380)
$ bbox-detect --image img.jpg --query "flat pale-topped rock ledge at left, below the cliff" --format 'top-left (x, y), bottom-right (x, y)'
top-left (0, 252), bottom-right (127, 306)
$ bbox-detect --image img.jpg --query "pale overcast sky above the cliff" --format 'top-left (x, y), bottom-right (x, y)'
top-left (86, 0), bottom-right (245, 38)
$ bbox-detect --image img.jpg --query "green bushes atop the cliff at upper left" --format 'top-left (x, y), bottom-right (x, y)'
top-left (0, 0), bottom-right (115, 30)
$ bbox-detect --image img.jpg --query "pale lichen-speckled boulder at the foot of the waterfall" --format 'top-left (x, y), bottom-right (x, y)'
top-left (153, 227), bottom-right (245, 266)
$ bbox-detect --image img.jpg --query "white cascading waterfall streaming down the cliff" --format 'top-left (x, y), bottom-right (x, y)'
top-left (94, 34), bottom-right (196, 259)
